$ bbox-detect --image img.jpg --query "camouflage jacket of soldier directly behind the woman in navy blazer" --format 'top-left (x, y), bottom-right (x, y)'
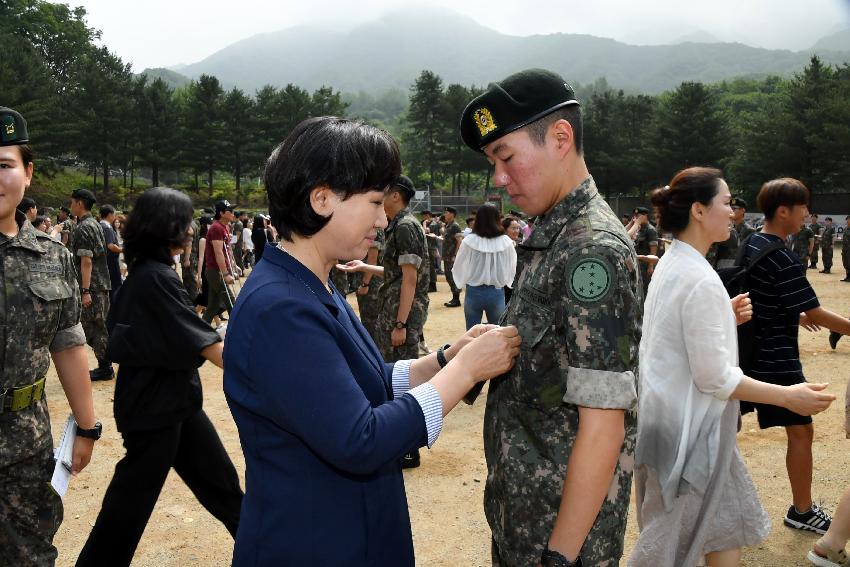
top-left (378, 208), bottom-right (431, 329)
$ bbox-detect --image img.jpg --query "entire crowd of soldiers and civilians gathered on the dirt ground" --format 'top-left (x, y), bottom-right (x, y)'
top-left (0, 64), bottom-right (850, 567)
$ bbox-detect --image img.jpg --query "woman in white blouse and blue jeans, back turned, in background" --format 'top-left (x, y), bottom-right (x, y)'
top-left (452, 205), bottom-right (516, 329)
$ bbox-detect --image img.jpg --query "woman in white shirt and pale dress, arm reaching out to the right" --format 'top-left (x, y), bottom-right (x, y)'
top-left (629, 167), bottom-right (835, 567)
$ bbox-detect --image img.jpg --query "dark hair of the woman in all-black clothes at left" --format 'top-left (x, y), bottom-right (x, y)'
top-left (122, 187), bottom-right (194, 266)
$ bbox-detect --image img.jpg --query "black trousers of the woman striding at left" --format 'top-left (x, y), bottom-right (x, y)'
top-left (77, 411), bottom-right (243, 567)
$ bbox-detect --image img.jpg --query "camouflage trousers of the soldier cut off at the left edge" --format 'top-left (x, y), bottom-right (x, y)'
top-left (0, 448), bottom-right (63, 567)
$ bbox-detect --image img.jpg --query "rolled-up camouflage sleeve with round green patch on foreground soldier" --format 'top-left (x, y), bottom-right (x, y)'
top-left (564, 244), bottom-right (641, 410)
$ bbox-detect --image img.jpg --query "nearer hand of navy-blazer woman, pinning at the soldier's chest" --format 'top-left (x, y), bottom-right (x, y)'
top-left (454, 326), bottom-right (522, 382)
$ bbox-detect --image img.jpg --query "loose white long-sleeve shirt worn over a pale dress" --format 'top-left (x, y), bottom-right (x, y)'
top-left (635, 240), bottom-right (743, 510)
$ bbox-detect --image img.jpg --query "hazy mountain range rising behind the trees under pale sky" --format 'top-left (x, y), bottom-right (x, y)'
top-left (174, 8), bottom-right (850, 94)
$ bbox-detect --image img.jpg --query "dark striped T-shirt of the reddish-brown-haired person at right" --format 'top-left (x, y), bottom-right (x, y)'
top-left (747, 232), bottom-right (820, 385)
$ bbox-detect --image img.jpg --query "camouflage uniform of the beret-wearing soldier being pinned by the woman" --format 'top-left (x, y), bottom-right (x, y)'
top-left (484, 177), bottom-right (642, 567)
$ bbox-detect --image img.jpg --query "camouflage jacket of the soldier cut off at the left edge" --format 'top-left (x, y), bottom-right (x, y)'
top-left (0, 213), bottom-right (86, 469)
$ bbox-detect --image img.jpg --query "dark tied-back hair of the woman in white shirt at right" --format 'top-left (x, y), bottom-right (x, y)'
top-left (650, 167), bottom-right (723, 236)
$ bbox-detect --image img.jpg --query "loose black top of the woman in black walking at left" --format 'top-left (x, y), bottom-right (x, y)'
top-left (107, 259), bottom-right (221, 431)
